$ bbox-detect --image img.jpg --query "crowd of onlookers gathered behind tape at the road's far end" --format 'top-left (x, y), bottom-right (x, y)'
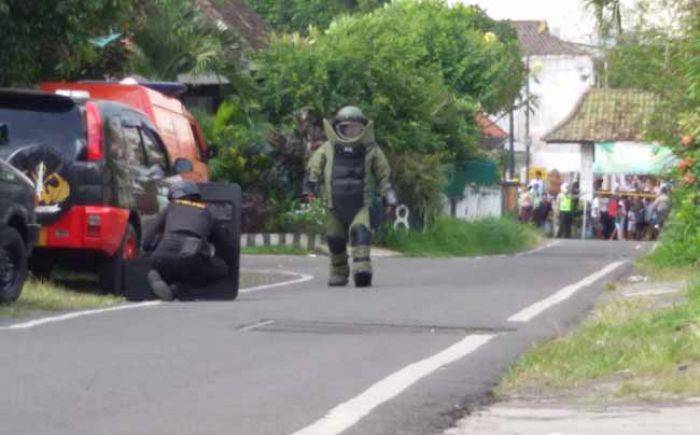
top-left (518, 173), bottom-right (671, 240)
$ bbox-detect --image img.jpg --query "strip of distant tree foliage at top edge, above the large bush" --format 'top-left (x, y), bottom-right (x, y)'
top-left (246, 0), bottom-right (389, 33)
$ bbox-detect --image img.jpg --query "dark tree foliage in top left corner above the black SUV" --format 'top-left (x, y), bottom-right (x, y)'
top-left (0, 0), bottom-right (136, 86)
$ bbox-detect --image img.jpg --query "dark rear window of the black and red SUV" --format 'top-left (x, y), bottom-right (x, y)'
top-left (0, 97), bottom-right (86, 158)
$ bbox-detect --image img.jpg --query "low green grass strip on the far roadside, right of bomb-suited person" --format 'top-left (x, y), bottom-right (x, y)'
top-left (382, 217), bottom-right (540, 257)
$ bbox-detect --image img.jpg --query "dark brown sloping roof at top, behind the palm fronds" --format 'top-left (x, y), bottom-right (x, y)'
top-left (195, 0), bottom-right (268, 49)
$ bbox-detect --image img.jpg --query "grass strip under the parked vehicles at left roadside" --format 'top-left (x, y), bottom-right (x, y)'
top-left (0, 277), bottom-right (124, 318)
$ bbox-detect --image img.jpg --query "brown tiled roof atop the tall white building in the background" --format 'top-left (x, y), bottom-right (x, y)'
top-left (512, 21), bottom-right (588, 56)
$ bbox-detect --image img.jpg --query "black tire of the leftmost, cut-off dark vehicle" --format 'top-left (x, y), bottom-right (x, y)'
top-left (0, 227), bottom-right (28, 303)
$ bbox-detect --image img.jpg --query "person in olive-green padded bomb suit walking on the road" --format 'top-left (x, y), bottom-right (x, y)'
top-left (304, 106), bottom-right (397, 287)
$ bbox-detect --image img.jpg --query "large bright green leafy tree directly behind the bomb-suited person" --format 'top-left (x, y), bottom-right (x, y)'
top-left (249, 0), bottom-right (524, 221)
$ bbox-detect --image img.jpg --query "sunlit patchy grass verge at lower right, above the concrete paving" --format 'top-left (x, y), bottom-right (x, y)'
top-left (496, 271), bottom-right (700, 399)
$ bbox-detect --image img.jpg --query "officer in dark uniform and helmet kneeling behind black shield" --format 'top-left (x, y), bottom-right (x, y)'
top-left (143, 181), bottom-right (228, 301)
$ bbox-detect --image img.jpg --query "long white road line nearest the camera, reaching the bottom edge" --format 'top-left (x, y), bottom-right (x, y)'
top-left (294, 335), bottom-right (495, 435)
